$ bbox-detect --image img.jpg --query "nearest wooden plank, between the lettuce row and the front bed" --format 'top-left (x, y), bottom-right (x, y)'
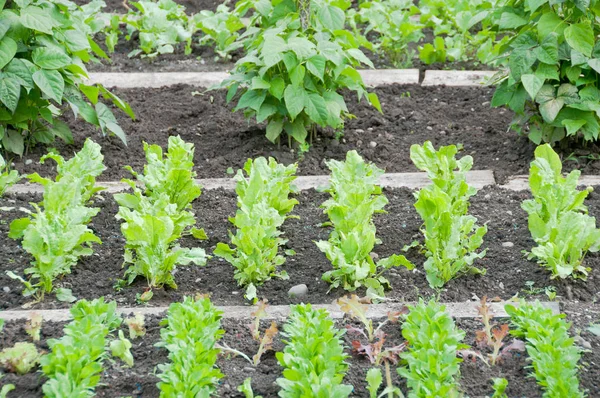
top-left (0, 301), bottom-right (560, 322)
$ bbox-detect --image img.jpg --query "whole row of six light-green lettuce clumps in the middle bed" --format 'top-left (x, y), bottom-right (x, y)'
top-left (2, 137), bottom-right (600, 304)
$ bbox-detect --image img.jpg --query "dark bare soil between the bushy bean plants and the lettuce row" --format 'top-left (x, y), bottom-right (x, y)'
top-left (13, 85), bottom-right (600, 183)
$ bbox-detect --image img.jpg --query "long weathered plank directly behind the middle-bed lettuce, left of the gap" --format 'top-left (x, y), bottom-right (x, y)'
top-left (8, 170), bottom-right (496, 193)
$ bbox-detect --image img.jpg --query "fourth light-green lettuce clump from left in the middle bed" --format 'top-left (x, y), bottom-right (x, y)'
top-left (317, 151), bottom-right (413, 298)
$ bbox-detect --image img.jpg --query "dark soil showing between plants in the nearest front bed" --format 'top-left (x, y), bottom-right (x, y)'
top-left (0, 305), bottom-right (600, 398)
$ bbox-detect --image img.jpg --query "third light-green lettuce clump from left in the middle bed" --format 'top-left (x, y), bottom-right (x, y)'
top-left (214, 157), bottom-right (298, 300)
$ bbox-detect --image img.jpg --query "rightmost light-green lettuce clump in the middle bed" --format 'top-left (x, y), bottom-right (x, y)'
top-left (521, 144), bottom-right (600, 279)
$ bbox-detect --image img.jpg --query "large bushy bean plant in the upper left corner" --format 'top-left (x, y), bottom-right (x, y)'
top-left (0, 0), bottom-right (134, 155)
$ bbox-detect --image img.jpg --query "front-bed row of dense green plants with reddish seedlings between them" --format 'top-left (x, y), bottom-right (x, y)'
top-left (0, 296), bottom-right (585, 398)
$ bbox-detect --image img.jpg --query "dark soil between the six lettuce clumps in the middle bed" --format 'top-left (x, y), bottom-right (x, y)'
top-left (0, 188), bottom-right (600, 309)
